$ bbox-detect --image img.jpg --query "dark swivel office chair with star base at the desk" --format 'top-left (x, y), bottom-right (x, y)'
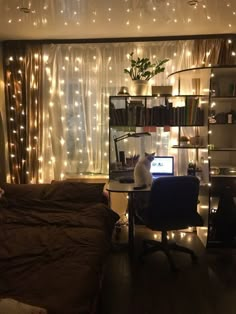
top-left (140, 176), bottom-right (203, 271)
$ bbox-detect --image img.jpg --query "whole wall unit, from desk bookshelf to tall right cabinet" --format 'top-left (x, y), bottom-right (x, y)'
top-left (109, 67), bottom-right (236, 248)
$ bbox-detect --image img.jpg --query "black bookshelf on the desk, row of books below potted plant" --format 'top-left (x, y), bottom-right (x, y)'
top-left (109, 95), bottom-right (207, 178)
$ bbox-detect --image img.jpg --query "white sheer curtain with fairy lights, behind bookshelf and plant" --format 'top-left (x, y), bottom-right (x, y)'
top-left (40, 41), bottom-right (194, 182)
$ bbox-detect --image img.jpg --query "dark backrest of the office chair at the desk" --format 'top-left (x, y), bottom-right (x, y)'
top-left (147, 176), bottom-right (202, 230)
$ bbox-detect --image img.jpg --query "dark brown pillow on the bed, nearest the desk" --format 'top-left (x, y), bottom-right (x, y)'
top-left (41, 181), bottom-right (104, 203)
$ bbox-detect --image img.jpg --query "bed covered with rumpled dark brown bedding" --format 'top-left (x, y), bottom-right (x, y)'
top-left (0, 181), bottom-right (119, 314)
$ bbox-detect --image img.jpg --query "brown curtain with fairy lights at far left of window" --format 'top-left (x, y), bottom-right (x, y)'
top-left (3, 42), bottom-right (42, 183)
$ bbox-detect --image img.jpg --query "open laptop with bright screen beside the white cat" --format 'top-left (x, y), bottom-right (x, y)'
top-left (150, 156), bottom-right (174, 179)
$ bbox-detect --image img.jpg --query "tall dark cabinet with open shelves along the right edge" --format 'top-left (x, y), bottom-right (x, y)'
top-left (208, 67), bottom-right (236, 247)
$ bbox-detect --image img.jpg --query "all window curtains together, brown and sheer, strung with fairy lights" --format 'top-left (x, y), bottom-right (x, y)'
top-left (3, 39), bottom-right (235, 183)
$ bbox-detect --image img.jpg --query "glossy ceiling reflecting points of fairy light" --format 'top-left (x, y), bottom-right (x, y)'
top-left (0, 0), bottom-right (236, 40)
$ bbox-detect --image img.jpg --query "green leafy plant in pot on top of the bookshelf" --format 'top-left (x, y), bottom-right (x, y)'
top-left (124, 52), bottom-right (169, 95)
